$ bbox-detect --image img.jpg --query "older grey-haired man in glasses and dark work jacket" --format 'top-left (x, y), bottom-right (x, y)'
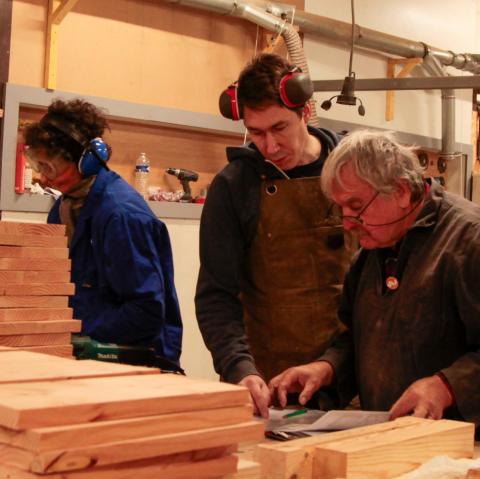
top-left (270, 130), bottom-right (480, 434)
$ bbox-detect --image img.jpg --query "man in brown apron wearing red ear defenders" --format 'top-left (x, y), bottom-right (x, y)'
top-left (195, 54), bottom-right (351, 417)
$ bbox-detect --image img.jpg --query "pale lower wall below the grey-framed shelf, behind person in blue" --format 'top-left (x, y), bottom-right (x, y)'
top-left (2, 211), bottom-right (218, 379)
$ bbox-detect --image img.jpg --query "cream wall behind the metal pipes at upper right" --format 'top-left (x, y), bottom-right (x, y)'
top-left (305, 0), bottom-right (480, 144)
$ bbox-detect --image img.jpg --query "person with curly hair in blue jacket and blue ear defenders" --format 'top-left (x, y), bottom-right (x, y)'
top-left (24, 99), bottom-right (182, 366)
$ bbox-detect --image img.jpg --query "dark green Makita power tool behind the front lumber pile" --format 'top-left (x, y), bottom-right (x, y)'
top-left (72, 334), bottom-right (185, 374)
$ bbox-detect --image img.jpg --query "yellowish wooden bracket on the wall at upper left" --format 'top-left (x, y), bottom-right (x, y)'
top-left (44, 0), bottom-right (78, 90)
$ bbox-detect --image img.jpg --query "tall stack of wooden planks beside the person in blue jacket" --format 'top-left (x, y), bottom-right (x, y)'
top-left (0, 221), bottom-right (81, 357)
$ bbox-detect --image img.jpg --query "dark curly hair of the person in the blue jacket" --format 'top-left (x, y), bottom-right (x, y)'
top-left (23, 98), bottom-right (110, 163)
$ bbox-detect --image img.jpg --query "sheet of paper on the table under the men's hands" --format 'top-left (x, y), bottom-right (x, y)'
top-left (266, 409), bottom-right (389, 432)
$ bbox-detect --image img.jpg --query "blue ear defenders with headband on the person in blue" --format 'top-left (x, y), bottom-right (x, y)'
top-left (40, 114), bottom-right (110, 176)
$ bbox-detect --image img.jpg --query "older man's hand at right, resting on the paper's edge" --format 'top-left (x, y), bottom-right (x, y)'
top-left (390, 376), bottom-right (453, 419)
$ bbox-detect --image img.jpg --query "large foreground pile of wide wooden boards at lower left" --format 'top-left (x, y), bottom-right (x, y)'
top-left (0, 350), bottom-right (263, 479)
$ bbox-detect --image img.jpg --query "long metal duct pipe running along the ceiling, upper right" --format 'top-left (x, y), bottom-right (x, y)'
top-left (162, 0), bottom-right (480, 74)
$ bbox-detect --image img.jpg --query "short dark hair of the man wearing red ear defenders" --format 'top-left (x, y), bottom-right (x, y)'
top-left (237, 53), bottom-right (303, 115)
